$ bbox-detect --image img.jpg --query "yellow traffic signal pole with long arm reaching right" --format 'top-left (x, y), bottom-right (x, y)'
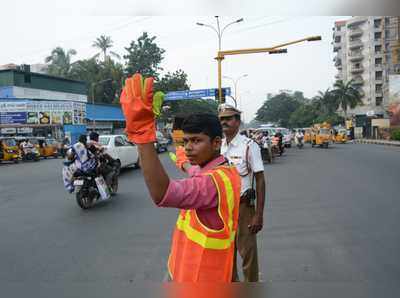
top-left (215, 36), bottom-right (321, 103)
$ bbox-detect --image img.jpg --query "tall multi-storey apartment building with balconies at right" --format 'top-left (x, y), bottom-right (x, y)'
top-left (333, 16), bottom-right (400, 136)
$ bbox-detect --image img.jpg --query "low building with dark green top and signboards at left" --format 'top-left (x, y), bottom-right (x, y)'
top-left (0, 68), bottom-right (87, 141)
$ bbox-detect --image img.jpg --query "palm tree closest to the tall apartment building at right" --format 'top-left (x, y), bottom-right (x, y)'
top-left (332, 80), bottom-right (363, 119)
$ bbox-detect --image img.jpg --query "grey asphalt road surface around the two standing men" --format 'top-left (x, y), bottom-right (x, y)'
top-left (0, 144), bottom-right (400, 297)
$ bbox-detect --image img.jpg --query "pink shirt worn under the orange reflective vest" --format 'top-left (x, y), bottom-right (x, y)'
top-left (158, 155), bottom-right (225, 230)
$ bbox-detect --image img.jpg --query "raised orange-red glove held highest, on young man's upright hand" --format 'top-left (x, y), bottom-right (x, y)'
top-left (120, 73), bottom-right (164, 144)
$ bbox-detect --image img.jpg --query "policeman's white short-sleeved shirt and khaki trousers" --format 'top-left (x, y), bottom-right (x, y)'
top-left (221, 133), bottom-right (264, 282)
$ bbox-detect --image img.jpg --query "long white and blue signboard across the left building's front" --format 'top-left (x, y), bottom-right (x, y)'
top-left (0, 101), bottom-right (86, 125)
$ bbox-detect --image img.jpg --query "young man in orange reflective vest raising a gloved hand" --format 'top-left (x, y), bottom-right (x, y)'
top-left (120, 74), bottom-right (240, 282)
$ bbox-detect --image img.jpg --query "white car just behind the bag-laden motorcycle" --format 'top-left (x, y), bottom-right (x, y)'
top-left (99, 135), bottom-right (139, 168)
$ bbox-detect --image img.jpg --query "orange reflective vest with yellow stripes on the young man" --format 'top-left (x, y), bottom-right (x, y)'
top-left (168, 166), bottom-right (241, 282)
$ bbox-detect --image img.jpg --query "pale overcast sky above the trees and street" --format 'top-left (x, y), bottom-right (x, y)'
top-left (0, 0), bottom-right (356, 121)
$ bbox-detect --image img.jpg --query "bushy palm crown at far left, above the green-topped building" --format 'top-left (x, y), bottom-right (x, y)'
top-left (45, 47), bottom-right (76, 77)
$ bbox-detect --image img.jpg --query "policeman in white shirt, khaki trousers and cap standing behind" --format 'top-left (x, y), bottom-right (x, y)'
top-left (218, 105), bottom-right (265, 282)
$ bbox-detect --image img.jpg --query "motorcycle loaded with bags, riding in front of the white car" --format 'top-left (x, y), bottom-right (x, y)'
top-left (73, 157), bottom-right (120, 209)
